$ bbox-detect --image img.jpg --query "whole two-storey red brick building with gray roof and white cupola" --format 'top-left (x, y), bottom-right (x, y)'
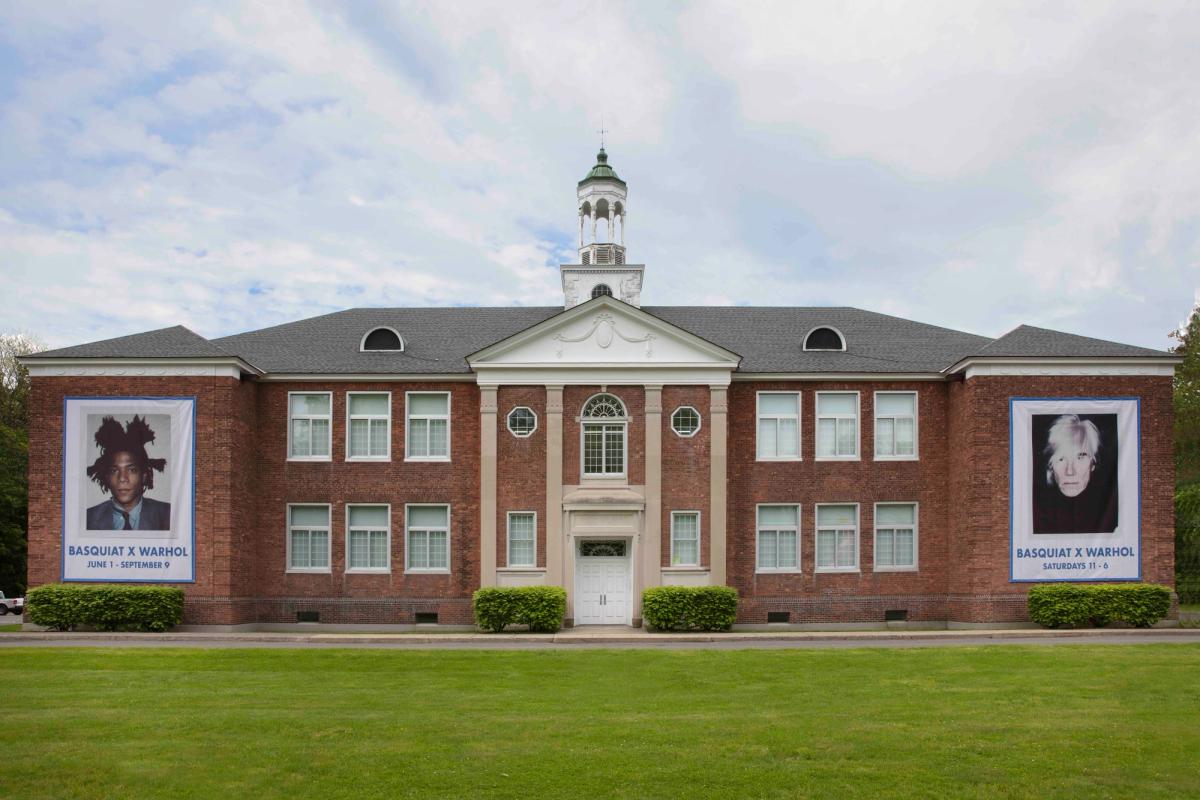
top-left (24, 150), bottom-right (1177, 625)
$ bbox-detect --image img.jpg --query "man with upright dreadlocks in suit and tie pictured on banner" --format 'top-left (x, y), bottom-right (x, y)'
top-left (88, 415), bottom-right (170, 530)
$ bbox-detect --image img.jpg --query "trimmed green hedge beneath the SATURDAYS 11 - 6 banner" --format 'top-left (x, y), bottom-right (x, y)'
top-left (1028, 583), bottom-right (1171, 627)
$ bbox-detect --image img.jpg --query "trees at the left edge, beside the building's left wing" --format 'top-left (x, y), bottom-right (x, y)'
top-left (0, 333), bottom-right (46, 595)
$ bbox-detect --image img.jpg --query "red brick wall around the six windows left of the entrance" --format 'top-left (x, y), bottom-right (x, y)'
top-left (254, 383), bottom-right (479, 622)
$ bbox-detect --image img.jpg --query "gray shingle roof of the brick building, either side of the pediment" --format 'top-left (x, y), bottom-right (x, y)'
top-left (30, 306), bottom-right (1169, 375)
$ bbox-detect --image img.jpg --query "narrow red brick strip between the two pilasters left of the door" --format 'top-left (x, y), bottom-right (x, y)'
top-left (496, 386), bottom-right (546, 567)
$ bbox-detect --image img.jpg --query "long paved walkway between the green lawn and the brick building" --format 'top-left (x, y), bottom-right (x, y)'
top-left (0, 627), bottom-right (1200, 650)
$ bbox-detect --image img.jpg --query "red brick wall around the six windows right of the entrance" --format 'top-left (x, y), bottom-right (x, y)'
top-left (726, 381), bottom-right (948, 622)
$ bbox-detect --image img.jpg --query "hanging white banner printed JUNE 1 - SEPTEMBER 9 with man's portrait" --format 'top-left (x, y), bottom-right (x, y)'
top-left (62, 397), bottom-right (196, 583)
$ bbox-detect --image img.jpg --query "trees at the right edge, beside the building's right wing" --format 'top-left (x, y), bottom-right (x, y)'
top-left (1171, 305), bottom-right (1200, 603)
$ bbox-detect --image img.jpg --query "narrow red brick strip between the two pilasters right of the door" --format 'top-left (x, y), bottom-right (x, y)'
top-left (661, 386), bottom-right (712, 567)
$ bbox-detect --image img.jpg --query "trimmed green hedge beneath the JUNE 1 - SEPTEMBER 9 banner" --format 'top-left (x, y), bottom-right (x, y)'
top-left (25, 583), bottom-right (184, 631)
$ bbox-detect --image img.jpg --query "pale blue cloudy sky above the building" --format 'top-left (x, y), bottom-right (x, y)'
top-left (0, 0), bottom-right (1200, 349)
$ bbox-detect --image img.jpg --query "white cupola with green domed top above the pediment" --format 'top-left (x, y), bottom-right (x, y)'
top-left (559, 145), bottom-right (646, 308)
